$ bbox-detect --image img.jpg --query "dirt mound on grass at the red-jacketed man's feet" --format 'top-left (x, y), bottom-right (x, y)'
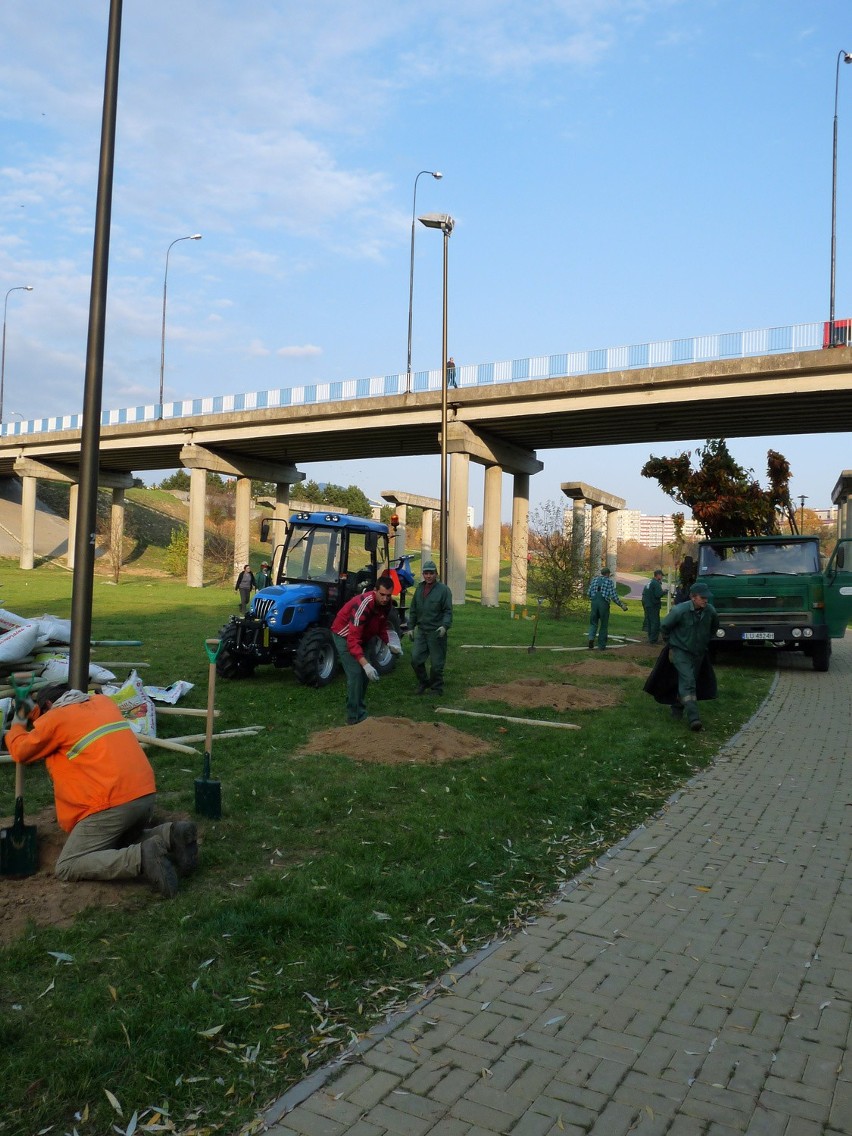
top-left (301, 718), bottom-right (491, 766)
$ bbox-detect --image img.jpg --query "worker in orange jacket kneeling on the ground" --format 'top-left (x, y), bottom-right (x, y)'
top-left (6, 683), bottom-right (198, 896)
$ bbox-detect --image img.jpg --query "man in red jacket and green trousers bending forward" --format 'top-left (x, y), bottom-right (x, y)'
top-left (332, 576), bottom-right (402, 726)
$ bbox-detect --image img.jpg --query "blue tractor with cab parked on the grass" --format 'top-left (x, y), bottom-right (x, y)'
top-left (216, 512), bottom-right (414, 686)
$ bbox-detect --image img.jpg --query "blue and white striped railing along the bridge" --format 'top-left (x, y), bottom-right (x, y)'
top-left (0, 319), bottom-right (852, 437)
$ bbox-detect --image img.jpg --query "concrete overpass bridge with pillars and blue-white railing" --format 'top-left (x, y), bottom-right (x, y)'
top-left (0, 324), bottom-right (852, 603)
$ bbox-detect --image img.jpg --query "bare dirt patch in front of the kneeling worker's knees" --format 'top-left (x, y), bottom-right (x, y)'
top-left (0, 808), bottom-right (153, 943)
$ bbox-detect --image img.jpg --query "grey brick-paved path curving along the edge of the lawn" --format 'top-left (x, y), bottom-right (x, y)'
top-left (266, 638), bottom-right (852, 1136)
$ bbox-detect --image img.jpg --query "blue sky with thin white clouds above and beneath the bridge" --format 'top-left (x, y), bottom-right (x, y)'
top-left (0, 0), bottom-right (852, 524)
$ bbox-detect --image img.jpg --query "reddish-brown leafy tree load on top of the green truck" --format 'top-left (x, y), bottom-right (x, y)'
top-left (642, 438), bottom-right (797, 540)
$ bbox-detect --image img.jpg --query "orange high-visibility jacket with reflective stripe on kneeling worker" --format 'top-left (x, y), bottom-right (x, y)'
top-left (6, 694), bottom-right (156, 833)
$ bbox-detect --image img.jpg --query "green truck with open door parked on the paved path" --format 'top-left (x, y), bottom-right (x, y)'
top-left (698, 536), bottom-right (852, 670)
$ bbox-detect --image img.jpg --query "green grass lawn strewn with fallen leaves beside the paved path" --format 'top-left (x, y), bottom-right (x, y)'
top-left (0, 563), bottom-right (772, 1136)
